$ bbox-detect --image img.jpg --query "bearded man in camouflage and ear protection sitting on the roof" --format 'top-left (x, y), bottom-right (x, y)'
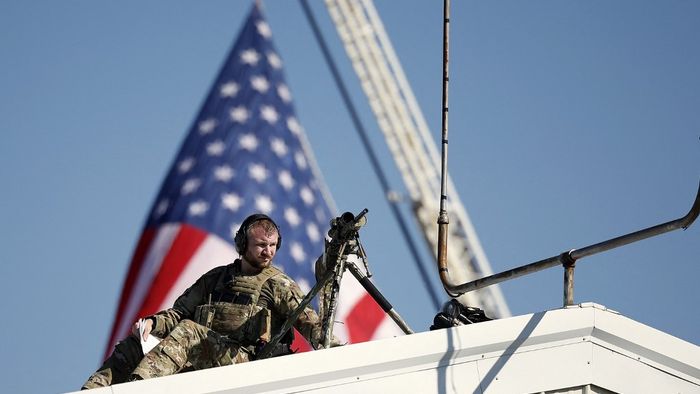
top-left (82, 214), bottom-right (330, 389)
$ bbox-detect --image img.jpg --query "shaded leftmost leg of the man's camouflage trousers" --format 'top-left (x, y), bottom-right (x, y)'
top-left (82, 335), bottom-right (143, 389)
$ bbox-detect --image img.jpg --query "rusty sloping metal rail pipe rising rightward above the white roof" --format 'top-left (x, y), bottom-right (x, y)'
top-left (439, 184), bottom-right (700, 296)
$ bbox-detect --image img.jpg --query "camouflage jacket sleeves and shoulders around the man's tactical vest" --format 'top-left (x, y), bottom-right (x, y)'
top-left (151, 260), bottom-right (321, 349)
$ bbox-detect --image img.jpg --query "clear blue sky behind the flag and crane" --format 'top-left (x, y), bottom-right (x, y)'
top-left (0, 0), bottom-right (700, 392)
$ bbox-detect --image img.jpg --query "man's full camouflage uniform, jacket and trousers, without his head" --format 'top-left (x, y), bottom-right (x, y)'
top-left (83, 260), bottom-right (321, 388)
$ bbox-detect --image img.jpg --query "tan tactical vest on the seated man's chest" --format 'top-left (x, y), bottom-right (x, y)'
top-left (195, 267), bottom-right (281, 345)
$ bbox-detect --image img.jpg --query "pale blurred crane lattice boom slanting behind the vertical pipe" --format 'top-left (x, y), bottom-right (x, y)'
top-left (326, 0), bottom-right (510, 317)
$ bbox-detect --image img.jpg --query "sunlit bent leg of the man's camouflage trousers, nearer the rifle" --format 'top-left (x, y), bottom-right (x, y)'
top-left (132, 320), bottom-right (249, 379)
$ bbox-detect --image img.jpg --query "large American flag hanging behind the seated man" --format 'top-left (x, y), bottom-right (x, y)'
top-left (105, 4), bottom-right (398, 356)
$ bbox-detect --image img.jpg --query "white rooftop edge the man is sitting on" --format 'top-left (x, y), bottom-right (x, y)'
top-left (75, 303), bottom-right (700, 394)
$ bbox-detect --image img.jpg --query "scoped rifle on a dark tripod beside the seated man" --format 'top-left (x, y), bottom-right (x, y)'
top-left (256, 209), bottom-right (413, 359)
